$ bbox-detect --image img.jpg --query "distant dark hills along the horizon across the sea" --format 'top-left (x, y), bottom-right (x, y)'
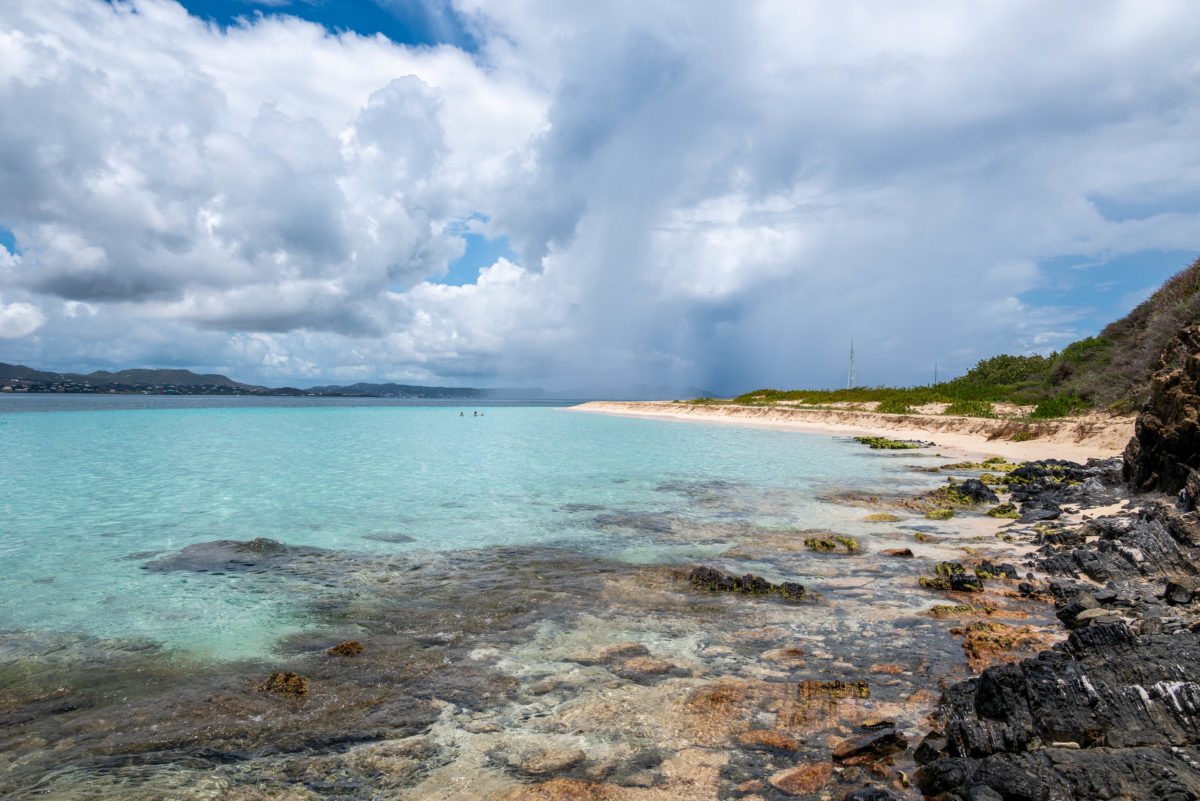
top-left (0, 362), bottom-right (710, 401)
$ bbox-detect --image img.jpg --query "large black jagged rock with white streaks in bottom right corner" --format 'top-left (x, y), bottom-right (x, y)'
top-left (918, 622), bottom-right (1200, 801)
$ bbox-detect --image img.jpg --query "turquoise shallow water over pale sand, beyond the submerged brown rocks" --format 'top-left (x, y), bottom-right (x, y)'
top-left (0, 398), bottom-right (931, 658)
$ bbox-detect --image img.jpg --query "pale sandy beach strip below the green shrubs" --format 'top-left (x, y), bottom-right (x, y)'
top-left (568, 401), bottom-right (1134, 462)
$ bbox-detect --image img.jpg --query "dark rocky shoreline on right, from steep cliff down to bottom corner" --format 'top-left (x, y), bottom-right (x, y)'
top-left (914, 329), bottom-right (1200, 801)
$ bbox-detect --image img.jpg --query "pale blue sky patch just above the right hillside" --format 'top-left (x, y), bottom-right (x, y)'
top-left (1021, 251), bottom-right (1196, 336)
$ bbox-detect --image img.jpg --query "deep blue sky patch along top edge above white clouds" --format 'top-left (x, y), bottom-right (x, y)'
top-left (169, 0), bottom-right (479, 52)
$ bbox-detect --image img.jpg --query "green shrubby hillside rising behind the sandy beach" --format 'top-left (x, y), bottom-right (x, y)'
top-left (720, 259), bottom-right (1200, 418)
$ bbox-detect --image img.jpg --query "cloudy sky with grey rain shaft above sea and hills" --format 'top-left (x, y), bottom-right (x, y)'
top-left (0, 0), bottom-right (1200, 395)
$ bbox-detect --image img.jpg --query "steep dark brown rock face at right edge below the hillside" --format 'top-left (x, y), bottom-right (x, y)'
top-left (1124, 325), bottom-right (1200, 508)
